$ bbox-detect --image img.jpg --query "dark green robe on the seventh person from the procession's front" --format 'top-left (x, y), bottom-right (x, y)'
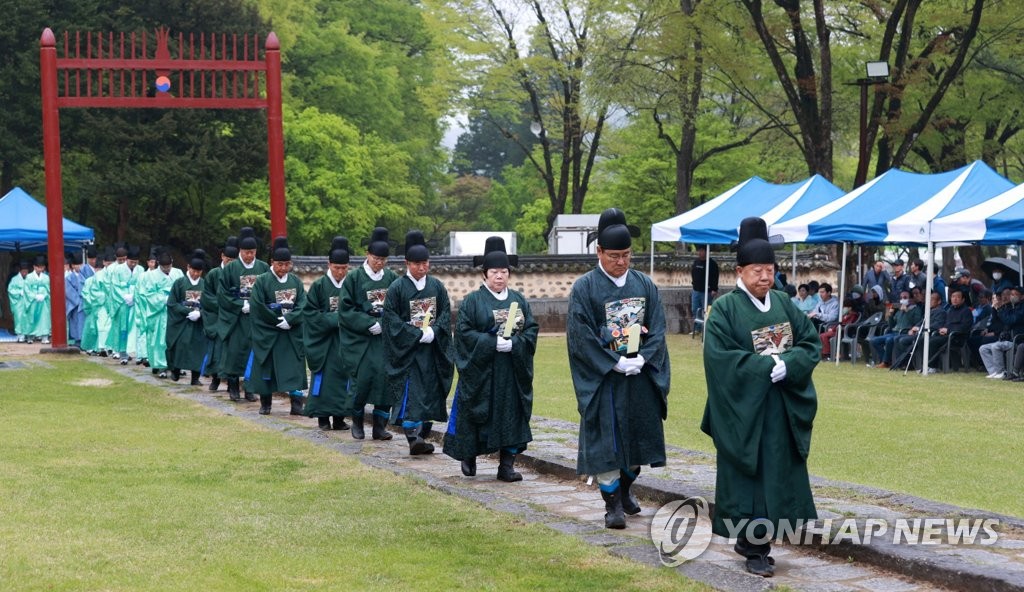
top-left (246, 271), bottom-right (308, 394)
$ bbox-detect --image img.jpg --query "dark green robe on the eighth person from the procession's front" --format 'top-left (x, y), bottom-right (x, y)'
top-left (217, 259), bottom-right (270, 377)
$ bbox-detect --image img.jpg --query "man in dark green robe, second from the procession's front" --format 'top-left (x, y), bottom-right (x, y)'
top-left (566, 208), bottom-right (672, 528)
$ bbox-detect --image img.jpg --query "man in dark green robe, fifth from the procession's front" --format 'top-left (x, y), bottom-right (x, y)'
top-left (338, 226), bottom-right (398, 440)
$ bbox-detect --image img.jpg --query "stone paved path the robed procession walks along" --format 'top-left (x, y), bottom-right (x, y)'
top-left (74, 352), bottom-right (1024, 592)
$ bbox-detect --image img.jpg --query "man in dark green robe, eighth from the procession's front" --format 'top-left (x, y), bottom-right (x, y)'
top-left (217, 226), bottom-right (270, 400)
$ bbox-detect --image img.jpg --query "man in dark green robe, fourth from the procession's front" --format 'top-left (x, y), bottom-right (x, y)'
top-left (381, 230), bottom-right (455, 455)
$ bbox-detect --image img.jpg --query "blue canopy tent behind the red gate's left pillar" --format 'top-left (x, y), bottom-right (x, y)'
top-left (0, 187), bottom-right (94, 251)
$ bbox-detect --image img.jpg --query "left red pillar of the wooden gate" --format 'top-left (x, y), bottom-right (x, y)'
top-left (39, 29), bottom-right (71, 351)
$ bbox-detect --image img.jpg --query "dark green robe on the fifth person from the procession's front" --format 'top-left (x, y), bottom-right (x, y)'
top-left (338, 264), bottom-right (398, 407)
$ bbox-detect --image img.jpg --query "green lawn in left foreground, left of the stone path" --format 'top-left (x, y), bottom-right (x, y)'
top-left (0, 356), bottom-right (705, 592)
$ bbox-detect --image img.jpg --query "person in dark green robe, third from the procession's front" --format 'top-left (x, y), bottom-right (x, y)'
top-left (444, 237), bottom-right (540, 482)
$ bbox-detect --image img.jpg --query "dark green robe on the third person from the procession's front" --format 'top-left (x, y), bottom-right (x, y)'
top-left (444, 286), bottom-right (540, 460)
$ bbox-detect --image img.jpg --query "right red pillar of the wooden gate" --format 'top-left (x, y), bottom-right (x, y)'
top-left (265, 33), bottom-right (288, 237)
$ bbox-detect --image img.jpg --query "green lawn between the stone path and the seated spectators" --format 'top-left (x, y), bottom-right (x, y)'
top-left (534, 335), bottom-right (1024, 516)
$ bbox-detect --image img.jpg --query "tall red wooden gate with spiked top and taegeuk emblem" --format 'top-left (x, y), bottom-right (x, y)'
top-left (39, 28), bottom-right (288, 350)
